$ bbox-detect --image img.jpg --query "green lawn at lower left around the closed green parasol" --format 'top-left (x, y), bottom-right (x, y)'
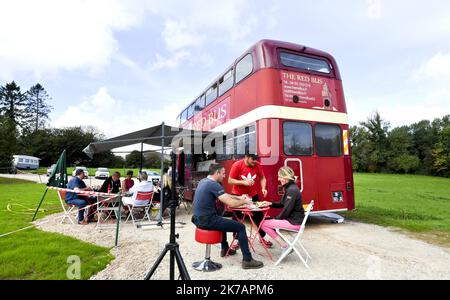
top-left (0, 178), bottom-right (113, 279)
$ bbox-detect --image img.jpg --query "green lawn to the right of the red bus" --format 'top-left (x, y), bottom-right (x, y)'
top-left (346, 174), bottom-right (450, 246)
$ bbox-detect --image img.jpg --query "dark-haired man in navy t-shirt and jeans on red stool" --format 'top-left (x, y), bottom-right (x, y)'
top-left (192, 164), bottom-right (264, 269)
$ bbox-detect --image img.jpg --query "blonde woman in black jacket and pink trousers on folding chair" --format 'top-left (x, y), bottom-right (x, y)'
top-left (261, 167), bottom-right (305, 251)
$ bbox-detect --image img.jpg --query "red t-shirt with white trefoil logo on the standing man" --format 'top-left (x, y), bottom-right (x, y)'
top-left (230, 160), bottom-right (264, 198)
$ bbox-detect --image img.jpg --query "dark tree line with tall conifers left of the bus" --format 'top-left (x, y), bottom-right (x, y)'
top-left (0, 81), bottom-right (160, 172)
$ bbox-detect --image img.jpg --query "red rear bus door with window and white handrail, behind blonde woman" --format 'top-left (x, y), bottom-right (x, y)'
top-left (279, 121), bottom-right (317, 204)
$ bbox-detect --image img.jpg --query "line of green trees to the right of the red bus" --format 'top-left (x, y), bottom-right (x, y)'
top-left (350, 112), bottom-right (450, 177)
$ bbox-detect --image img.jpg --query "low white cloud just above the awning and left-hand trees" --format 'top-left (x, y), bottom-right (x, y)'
top-left (52, 87), bottom-right (181, 138)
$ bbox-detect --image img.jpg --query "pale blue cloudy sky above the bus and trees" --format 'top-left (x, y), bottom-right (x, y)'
top-left (0, 0), bottom-right (450, 141)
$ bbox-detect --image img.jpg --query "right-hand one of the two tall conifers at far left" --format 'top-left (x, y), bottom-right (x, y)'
top-left (25, 83), bottom-right (53, 132)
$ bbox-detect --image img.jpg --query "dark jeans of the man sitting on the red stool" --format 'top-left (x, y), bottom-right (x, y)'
top-left (192, 215), bottom-right (252, 261)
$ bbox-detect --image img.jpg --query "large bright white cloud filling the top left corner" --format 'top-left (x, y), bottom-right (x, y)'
top-left (0, 0), bottom-right (144, 76)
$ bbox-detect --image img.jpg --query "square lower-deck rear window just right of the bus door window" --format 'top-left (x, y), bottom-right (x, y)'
top-left (316, 124), bottom-right (342, 157)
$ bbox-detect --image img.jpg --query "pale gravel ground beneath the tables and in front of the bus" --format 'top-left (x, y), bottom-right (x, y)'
top-left (35, 207), bottom-right (450, 280)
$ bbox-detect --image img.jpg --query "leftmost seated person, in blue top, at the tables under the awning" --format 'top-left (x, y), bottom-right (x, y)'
top-left (65, 169), bottom-right (91, 225)
